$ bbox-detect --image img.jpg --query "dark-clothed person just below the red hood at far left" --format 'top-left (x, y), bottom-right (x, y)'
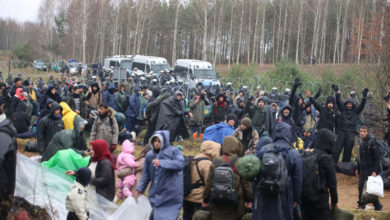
top-left (11, 102), bottom-right (35, 138)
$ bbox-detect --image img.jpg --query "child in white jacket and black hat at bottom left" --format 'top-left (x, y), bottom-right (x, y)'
top-left (66, 167), bottom-right (92, 220)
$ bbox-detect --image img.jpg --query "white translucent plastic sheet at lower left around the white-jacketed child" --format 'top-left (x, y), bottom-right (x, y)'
top-left (15, 154), bottom-right (152, 220)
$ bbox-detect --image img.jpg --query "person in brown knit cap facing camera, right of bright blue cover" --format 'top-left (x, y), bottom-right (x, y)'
top-left (232, 118), bottom-right (259, 155)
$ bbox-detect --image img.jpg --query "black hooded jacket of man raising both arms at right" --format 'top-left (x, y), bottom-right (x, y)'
top-left (336, 93), bottom-right (367, 132)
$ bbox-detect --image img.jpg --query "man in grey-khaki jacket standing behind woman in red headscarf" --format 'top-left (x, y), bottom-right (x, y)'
top-left (90, 104), bottom-right (119, 152)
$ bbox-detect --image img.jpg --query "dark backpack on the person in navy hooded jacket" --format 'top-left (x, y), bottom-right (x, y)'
top-left (257, 144), bottom-right (288, 194)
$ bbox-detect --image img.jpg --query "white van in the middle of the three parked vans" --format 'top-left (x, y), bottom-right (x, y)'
top-left (131, 55), bottom-right (171, 74)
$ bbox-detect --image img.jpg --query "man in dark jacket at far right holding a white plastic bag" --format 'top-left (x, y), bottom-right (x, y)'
top-left (356, 125), bottom-right (383, 211)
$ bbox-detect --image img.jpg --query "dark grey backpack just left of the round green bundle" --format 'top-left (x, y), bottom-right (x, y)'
top-left (210, 155), bottom-right (238, 204)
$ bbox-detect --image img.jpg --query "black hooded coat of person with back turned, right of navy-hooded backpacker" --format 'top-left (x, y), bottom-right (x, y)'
top-left (310, 128), bottom-right (338, 209)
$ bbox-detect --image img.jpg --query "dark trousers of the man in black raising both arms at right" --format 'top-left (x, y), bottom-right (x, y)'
top-left (332, 131), bottom-right (356, 164)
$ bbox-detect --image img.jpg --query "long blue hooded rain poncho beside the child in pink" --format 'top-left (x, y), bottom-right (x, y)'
top-left (137, 131), bottom-right (184, 220)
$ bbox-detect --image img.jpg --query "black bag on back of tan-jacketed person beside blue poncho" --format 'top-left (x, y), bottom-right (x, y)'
top-left (183, 156), bottom-right (209, 197)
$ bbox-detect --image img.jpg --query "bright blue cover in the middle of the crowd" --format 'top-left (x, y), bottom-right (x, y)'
top-left (203, 122), bottom-right (234, 145)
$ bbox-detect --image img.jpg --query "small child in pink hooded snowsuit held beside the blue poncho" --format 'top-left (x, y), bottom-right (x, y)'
top-left (116, 140), bottom-right (138, 199)
